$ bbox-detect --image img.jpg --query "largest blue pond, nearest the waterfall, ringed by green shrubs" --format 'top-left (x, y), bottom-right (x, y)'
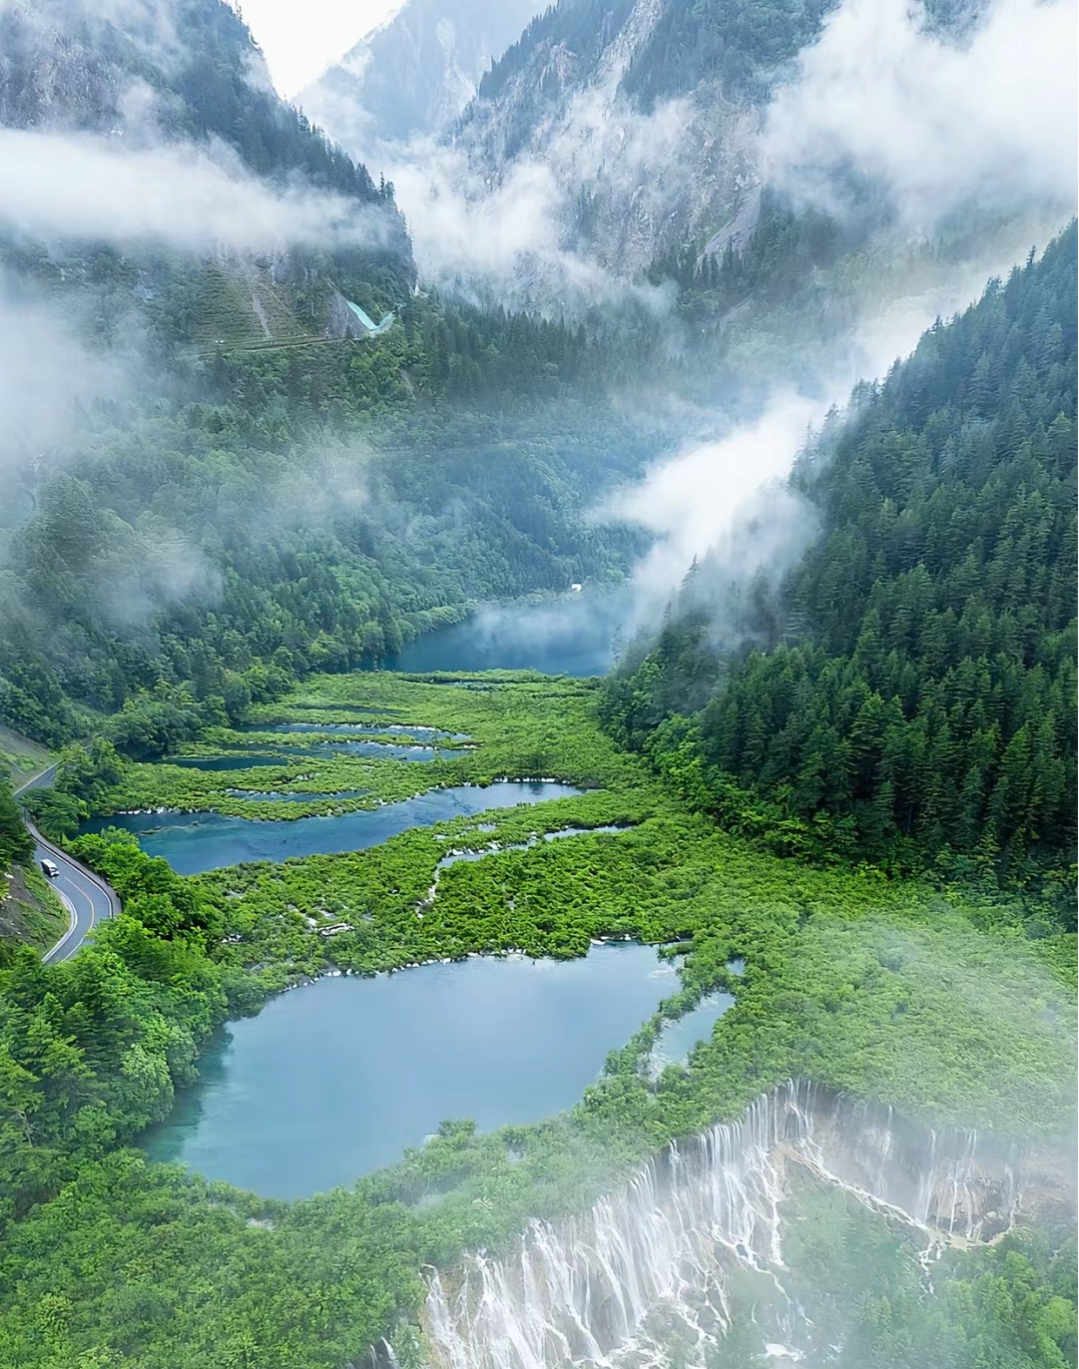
top-left (142, 945), bottom-right (678, 1198)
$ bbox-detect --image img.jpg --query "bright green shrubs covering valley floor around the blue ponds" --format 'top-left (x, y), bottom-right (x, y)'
top-left (0, 675), bottom-right (1075, 1369)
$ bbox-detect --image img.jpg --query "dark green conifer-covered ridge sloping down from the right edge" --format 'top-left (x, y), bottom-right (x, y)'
top-left (605, 226), bottom-right (1076, 876)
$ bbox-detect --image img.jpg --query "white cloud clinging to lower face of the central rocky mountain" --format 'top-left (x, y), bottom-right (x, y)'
top-left (388, 74), bottom-right (717, 312)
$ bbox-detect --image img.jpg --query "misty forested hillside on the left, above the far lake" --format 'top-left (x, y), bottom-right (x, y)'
top-left (0, 301), bottom-right (649, 753)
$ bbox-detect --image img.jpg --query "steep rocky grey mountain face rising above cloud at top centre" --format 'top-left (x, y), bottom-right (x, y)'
top-left (413, 0), bottom-right (830, 277)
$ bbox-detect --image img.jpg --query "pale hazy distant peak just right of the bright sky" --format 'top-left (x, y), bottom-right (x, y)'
top-left (297, 0), bottom-right (538, 148)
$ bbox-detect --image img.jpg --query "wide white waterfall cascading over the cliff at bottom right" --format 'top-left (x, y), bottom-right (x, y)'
top-left (426, 1080), bottom-right (1020, 1369)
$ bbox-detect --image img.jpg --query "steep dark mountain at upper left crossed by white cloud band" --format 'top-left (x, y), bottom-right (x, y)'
top-left (0, 0), bottom-right (415, 348)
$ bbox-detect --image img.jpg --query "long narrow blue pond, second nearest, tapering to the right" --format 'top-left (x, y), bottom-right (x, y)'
top-left (82, 780), bottom-right (582, 875)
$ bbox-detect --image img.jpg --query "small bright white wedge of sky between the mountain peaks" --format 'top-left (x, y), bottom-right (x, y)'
top-left (233, 0), bottom-right (403, 99)
